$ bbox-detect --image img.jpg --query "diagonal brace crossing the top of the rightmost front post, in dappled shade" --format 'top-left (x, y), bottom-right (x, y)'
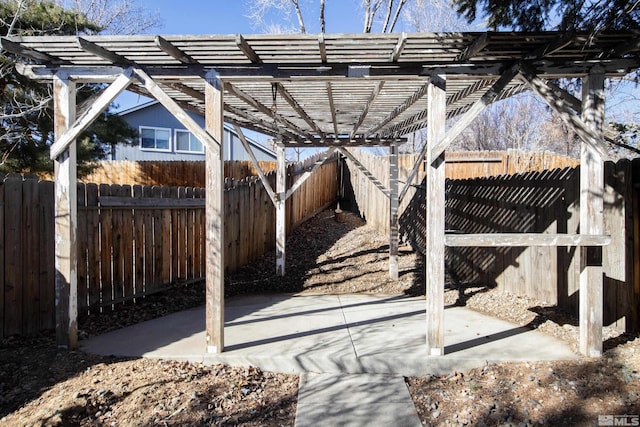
top-left (520, 66), bottom-right (608, 158)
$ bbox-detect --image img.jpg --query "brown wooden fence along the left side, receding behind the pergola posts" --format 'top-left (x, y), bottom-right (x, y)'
top-left (0, 157), bottom-right (338, 336)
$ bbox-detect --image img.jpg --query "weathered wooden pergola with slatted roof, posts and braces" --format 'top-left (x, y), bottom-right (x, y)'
top-left (0, 32), bottom-right (640, 356)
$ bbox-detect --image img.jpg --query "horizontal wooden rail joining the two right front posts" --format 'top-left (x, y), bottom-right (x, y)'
top-left (445, 233), bottom-right (611, 248)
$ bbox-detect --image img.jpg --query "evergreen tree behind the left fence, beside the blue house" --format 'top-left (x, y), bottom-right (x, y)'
top-left (0, 0), bottom-right (137, 175)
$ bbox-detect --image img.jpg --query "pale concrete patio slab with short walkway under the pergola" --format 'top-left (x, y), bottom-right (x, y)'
top-left (81, 295), bottom-right (577, 427)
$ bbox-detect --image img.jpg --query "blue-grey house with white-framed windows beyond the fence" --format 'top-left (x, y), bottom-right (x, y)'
top-left (111, 101), bottom-right (276, 161)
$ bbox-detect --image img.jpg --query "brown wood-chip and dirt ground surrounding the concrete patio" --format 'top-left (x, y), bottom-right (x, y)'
top-left (0, 211), bottom-right (640, 426)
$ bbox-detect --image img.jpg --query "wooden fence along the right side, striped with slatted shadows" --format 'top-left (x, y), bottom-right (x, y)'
top-left (346, 152), bottom-right (640, 331)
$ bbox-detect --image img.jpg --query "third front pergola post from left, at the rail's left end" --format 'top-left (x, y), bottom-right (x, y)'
top-left (425, 75), bottom-right (447, 356)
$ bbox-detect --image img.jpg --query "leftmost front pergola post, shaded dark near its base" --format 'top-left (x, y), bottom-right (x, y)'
top-left (53, 73), bottom-right (78, 349)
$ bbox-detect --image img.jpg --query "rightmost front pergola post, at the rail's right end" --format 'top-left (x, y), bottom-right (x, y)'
top-left (579, 67), bottom-right (604, 357)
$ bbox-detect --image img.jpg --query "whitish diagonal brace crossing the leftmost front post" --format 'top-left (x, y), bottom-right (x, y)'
top-left (49, 68), bottom-right (133, 159)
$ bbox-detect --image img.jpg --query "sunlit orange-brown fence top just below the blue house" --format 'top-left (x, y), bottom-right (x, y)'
top-left (41, 160), bottom-right (276, 188)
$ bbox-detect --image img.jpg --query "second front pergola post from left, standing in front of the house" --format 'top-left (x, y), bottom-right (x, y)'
top-left (205, 72), bottom-right (224, 353)
